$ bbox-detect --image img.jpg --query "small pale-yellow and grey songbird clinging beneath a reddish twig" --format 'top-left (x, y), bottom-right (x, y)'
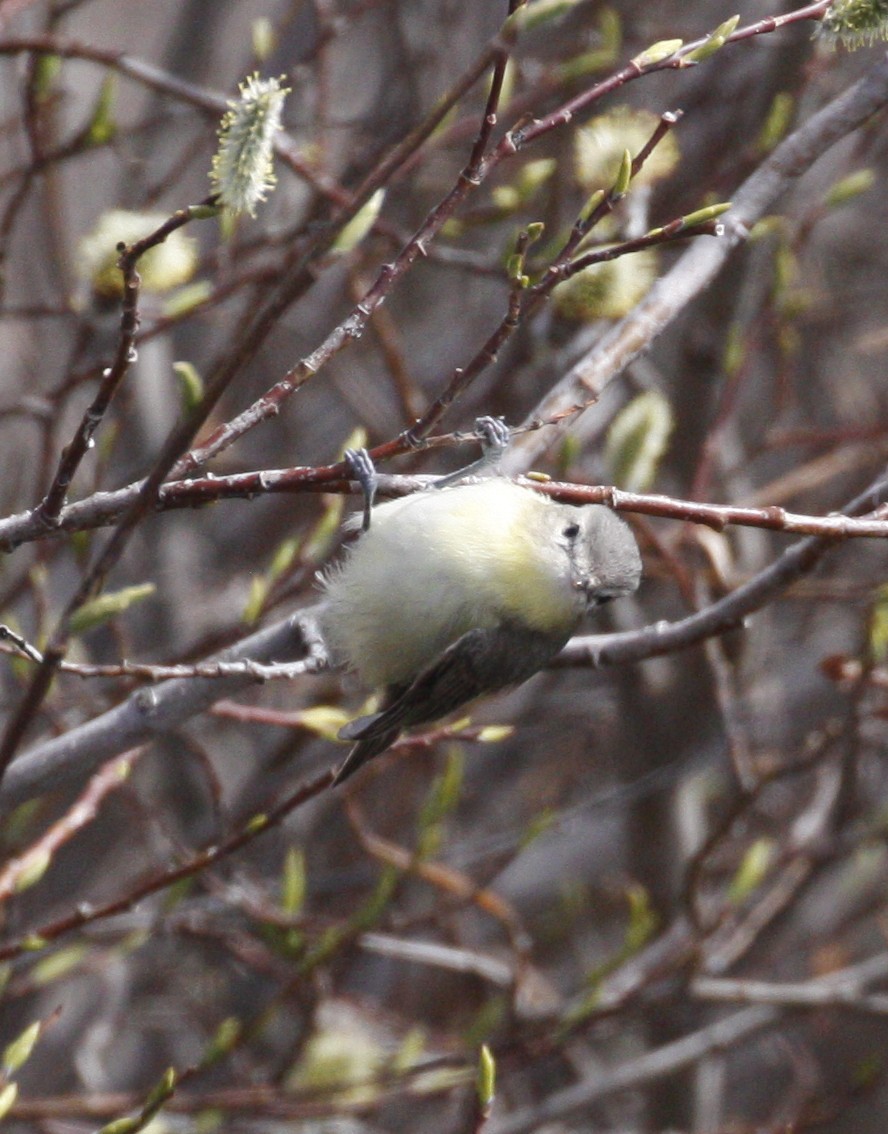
top-left (321, 455), bottom-right (641, 784)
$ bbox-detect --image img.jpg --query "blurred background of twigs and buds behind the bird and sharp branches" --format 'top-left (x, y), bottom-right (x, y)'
top-left (0, 0), bottom-right (888, 1134)
